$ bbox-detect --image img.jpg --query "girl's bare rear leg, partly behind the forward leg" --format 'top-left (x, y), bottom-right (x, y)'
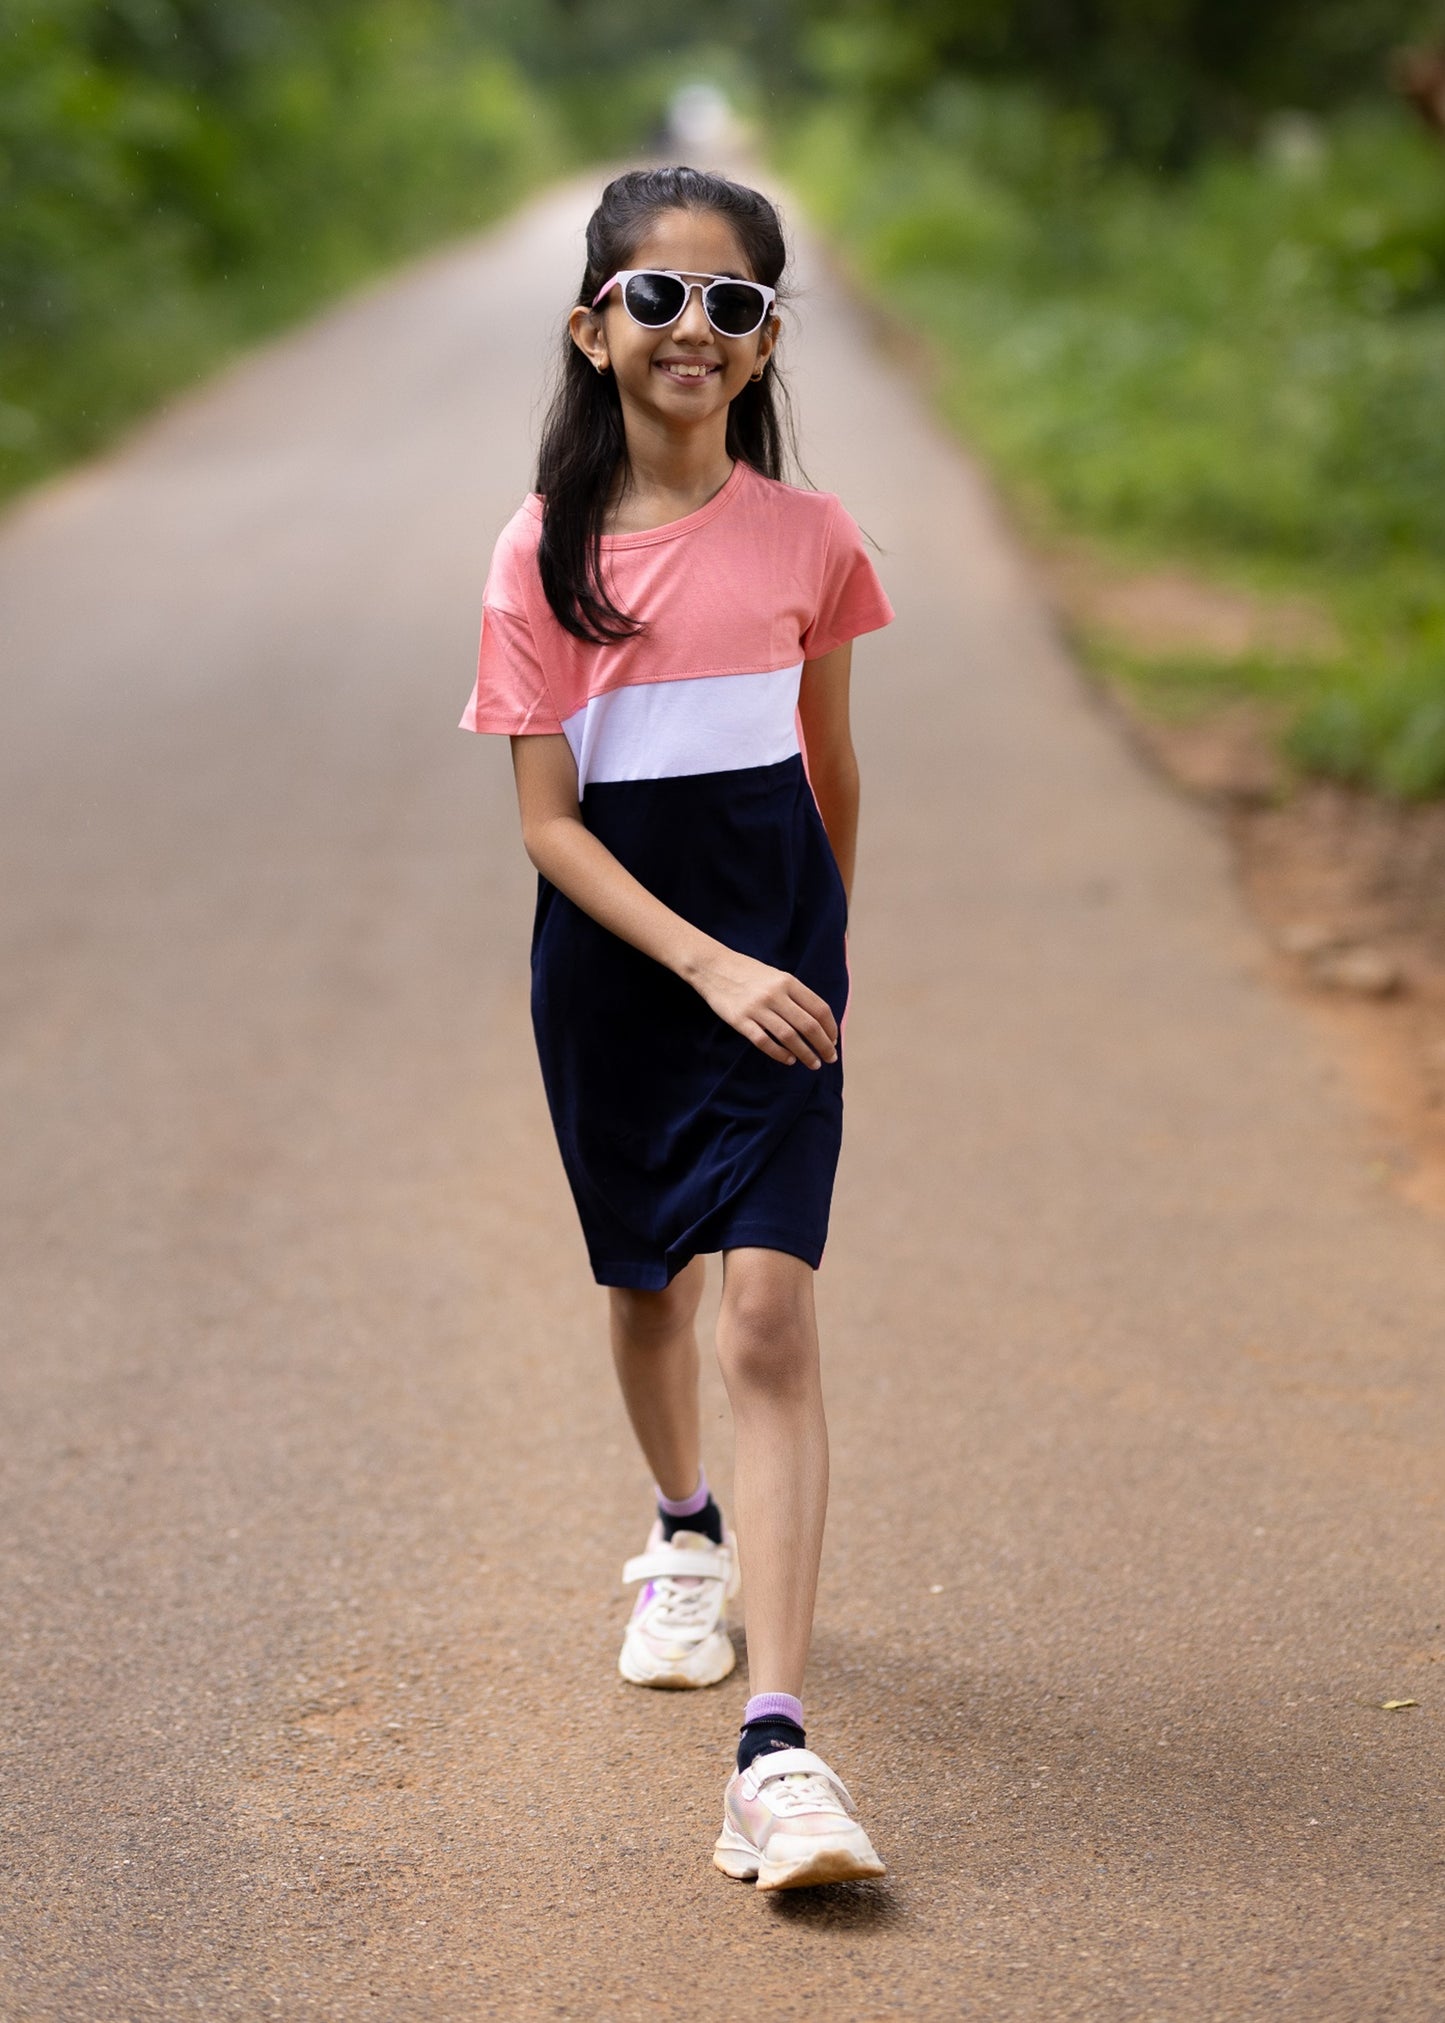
top-left (607, 1258), bottom-right (706, 1501)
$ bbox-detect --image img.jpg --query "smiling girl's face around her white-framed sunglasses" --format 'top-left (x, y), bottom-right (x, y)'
top-left (571, 210), bottom-right (781, 427)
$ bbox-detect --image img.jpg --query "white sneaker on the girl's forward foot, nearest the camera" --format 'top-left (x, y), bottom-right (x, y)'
top-left (712, 1750), bottom-right (886, 1889)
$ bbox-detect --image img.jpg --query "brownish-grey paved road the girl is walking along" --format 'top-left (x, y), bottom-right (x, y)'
top-left (0, 173), bottom-right (1445, 2023)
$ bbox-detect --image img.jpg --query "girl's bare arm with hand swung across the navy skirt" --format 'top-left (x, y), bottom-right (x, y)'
top-left (512, 732), bottom-right (838, 1068)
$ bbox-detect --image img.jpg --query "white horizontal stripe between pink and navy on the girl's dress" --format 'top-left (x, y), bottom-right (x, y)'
top-left (563, 659), bottom-right (803, 793)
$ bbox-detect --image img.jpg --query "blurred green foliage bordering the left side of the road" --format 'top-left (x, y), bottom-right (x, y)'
top-left (0, 0), bottom-right (567, 490)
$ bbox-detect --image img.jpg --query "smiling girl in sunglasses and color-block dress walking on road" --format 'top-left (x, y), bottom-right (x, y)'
top-left (461, 168), bottom-right (893, 1889)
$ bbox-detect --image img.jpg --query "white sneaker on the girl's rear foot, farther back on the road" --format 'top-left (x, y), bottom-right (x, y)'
top-left (617, 1519), bottom-right (741, 1687)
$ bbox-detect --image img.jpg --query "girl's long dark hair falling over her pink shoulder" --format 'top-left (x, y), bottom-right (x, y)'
top-left (536, 168), bottom-right (793, 645)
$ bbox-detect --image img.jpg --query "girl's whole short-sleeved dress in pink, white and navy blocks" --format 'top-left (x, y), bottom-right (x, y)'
top-left (461, 463), bottom-right (893, 1289)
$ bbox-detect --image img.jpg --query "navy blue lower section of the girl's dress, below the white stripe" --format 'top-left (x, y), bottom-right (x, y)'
top-left (532, 753), bottom-right (848, 1289)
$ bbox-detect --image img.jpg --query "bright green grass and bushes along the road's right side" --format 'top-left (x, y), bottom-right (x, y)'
top-left (781, 83), bottom-right (1445, 793)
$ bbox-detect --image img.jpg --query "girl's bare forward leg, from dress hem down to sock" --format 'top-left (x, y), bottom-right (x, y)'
top-left (718, 1246), bottom-right (828, 1697)
